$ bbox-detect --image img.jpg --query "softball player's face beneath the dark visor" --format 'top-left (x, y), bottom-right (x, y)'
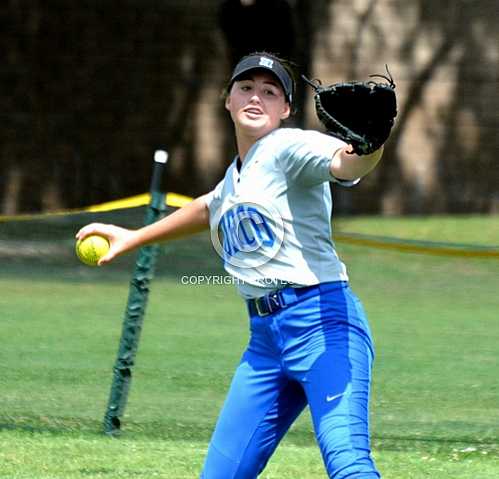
top-left (225, 71), bottom-right (290, 138)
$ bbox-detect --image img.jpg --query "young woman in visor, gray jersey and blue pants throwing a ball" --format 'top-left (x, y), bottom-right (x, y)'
top-left (77, 53), bottom-right (382, 479)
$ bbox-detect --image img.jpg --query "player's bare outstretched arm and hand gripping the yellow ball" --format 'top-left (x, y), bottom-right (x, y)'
top-left (76, 196), bottom-right (209, 265)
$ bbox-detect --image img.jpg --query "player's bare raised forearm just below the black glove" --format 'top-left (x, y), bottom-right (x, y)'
top-left (330, 145), bottom-right (383, 180)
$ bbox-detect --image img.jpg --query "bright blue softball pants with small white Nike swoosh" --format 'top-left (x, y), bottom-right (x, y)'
top-left (201, 282), bottom-right (381, 479)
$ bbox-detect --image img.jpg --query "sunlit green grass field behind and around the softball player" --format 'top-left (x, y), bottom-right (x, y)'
top-left (0, 217), bottom-right (499, 479)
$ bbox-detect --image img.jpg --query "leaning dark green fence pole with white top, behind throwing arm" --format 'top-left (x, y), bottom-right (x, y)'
top-left (104, 150), bottom-right (168, 435)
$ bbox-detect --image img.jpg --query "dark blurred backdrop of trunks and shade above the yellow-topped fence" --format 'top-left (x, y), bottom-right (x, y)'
top-left (0, 0), bottom-right (499, 215)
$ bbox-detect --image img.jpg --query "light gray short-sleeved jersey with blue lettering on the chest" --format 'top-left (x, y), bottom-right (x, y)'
top-left (206, 128), bottom-right (358, 298)
